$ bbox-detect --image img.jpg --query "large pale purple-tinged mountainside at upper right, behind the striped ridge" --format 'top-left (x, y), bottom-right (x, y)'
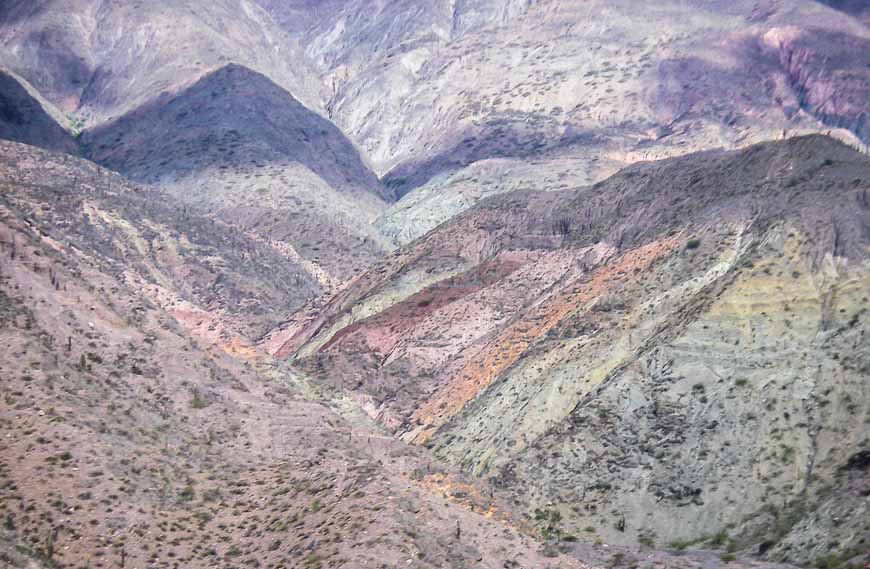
top-left (260, 0), bottom-right (870, 243)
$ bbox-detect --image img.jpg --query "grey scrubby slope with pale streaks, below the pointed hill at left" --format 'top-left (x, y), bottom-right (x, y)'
top-left (0, 141), bottom-right (322, 342)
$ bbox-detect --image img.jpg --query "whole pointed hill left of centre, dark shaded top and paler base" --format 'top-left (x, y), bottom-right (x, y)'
top-left (82, 65), bottom-right (386, 287)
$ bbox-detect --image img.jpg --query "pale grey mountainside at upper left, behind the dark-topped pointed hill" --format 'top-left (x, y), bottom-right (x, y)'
top-left (0, 0), bottom-right (321, 125)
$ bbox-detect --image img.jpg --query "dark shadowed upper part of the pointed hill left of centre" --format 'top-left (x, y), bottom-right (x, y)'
top-left (83, 65), bottom-right (383, 199)
